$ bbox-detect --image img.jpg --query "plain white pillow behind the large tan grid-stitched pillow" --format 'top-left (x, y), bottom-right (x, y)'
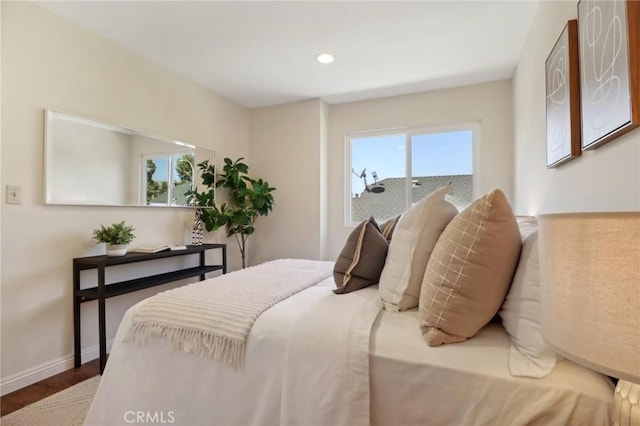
top-left (499, 218), bottom-right (556, 377)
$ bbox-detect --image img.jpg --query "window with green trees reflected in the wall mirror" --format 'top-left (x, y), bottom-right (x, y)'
top-left (142, 151), bottom-right (195, 206)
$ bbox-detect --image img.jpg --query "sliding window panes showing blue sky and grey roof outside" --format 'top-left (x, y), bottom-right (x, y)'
top-left (346, 125), bottom-right (476, 225)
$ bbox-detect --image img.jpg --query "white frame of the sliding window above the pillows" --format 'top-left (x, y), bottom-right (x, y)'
top-left (344, 121), bottom-right (480, 228)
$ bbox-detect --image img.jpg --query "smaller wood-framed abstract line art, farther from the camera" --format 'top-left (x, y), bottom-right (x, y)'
top-left (545, 19), bottom-right (581, 168)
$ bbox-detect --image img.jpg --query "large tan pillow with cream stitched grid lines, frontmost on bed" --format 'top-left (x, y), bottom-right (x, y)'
top-left (419, 189), bottom-right (521, 346)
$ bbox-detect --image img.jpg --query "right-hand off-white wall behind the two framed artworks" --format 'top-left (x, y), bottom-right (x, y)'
top-left (513, 1), bottom-right (640, 215)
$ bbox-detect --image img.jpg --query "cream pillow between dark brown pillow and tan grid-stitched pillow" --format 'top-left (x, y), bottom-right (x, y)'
top-left (378, 186), bottom-right (458, 311)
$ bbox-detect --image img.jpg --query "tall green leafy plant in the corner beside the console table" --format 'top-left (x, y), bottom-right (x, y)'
top-left (187, 157), bottom-right (276, 268)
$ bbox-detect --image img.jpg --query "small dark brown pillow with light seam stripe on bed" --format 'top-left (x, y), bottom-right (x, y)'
top-left (333, 217), bottom-right (389, 294)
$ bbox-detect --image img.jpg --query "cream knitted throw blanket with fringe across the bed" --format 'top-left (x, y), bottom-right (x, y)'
top-left (125, 259), bottom-right (333, 368)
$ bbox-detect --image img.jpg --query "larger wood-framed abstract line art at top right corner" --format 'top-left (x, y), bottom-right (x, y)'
top-left (578, 0), bottom-right (640, 149)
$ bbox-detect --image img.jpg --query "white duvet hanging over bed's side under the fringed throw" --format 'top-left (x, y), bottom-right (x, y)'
top-left (85, 278), bottom-right (382, 426)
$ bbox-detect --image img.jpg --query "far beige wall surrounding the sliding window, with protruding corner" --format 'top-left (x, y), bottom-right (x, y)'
top-left (250, 81), bottom-right (513, 264)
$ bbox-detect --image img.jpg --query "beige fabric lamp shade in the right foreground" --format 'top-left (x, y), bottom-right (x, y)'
top-left (539, 212), bottom-right (640, 383)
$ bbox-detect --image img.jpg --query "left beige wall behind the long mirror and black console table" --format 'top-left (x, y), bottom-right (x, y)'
top-left (0, 2), bottom-right (249, 393)
